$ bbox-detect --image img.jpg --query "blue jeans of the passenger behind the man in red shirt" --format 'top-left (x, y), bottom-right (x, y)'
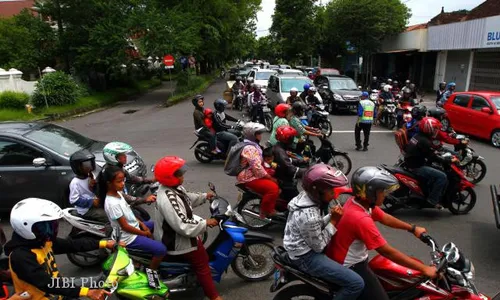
top-left (291, 250), bottom-right (364, 300)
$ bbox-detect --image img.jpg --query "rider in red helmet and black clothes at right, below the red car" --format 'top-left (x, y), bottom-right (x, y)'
top-left (404, 117), bottom-right (450, 209)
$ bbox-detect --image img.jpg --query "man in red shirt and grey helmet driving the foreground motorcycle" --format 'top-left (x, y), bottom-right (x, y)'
top-left (326, 167), bottom-right (437, 300)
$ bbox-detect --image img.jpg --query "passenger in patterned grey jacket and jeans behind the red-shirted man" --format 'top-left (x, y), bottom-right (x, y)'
top-left (283, 164), bottom-right (364, 300)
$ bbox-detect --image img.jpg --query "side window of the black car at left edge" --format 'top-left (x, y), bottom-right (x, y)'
top-left (0, 140), bottom-right (43, 166)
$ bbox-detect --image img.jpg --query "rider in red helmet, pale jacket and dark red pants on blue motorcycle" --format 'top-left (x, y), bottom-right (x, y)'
top-left (153, 156), bottom-right (222, 300)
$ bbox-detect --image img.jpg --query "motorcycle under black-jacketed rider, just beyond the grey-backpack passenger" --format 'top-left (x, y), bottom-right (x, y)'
top-left (189, 121), bottom-right (245, 164)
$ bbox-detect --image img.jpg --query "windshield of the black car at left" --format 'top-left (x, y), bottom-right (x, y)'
top-left (25, 124), bottom-right (93, 157)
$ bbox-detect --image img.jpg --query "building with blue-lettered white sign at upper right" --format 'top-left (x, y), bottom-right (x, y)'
top-left (373, 0), bottom-right (500, 91)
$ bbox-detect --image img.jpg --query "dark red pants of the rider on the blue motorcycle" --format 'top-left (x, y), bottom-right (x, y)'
top-left (184, 239), bottom-right (219, 300)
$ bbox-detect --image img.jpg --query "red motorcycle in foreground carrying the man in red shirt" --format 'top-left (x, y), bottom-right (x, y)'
top-left (270, 233), bottom-right (498, 300)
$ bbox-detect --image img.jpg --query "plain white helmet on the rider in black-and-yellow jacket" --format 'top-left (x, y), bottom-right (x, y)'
top-left (10, 198), bottom-right (63, 240)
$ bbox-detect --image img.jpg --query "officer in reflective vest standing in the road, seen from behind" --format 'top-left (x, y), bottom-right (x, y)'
top-left (354, 92), bottom-right (375, 151)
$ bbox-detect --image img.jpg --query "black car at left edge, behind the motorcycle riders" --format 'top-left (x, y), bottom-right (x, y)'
top-left (0, 122), bottom-right (147, 212)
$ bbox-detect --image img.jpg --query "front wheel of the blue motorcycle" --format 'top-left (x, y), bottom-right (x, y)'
top-left (231, 243), bottom-right (275, 281)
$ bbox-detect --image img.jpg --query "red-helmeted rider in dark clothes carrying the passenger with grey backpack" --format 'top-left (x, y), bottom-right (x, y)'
top-left (273, 126), bottom-right (309, 201)
